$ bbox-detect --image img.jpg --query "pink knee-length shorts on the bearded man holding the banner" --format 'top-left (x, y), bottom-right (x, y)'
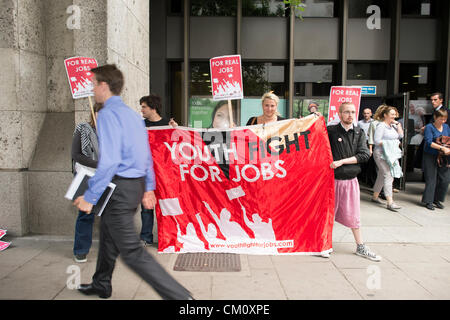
top-left (334, 178), bottom-right (361, 229)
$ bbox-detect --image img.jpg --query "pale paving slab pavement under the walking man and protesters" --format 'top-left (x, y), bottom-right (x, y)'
top-left (0, 183), bottom-right (450, 300)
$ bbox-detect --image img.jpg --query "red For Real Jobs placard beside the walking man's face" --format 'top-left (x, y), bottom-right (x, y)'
top-left (64, 57), bottom-right (97, 99)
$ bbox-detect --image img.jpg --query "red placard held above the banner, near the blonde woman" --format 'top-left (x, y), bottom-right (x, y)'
top-left (209, 55), bottom-right (244, 100)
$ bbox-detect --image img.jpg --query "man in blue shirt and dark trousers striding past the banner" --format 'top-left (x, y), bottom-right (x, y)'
top-left (74, 65), bottom-right (192, 300)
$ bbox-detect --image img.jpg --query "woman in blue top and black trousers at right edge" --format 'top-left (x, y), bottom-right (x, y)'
top-left (422, 108), bottom-right (450, 210)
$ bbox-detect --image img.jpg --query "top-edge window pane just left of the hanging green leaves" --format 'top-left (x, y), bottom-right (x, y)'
top-left (242, 0), bottom-right (287, 17)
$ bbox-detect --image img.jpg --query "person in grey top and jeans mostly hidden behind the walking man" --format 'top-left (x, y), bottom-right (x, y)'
top-left (72, 103), bottom-right (103, 263)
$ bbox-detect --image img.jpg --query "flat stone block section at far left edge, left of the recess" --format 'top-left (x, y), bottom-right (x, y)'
top-left (0, 0), bottom-right (47, 235)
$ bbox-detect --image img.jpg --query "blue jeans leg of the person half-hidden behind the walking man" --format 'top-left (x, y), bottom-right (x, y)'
top-left (73, 211), bottom-right (95, 255)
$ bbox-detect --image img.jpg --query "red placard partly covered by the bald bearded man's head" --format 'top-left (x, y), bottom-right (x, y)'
top-left (327, 87), bottom-right (361, 125)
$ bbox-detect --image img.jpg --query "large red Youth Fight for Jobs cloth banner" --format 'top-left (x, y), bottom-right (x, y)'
top-left (148, 115), bottom-right (334, 254)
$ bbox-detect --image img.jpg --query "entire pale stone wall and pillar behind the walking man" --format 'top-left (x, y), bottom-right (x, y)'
top-left (0, 0), bottom-right (149, 235)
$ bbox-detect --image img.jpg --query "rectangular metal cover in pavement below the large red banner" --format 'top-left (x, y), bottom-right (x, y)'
top-left (173, 252), bottom-right (241, 272)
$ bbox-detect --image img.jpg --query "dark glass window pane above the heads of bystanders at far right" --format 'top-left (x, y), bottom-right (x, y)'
top-left (399, 63), bottom-right (436, 100)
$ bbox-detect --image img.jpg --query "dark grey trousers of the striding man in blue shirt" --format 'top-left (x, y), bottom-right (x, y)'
top-left (92, 176), bottom-right (190, 300)
